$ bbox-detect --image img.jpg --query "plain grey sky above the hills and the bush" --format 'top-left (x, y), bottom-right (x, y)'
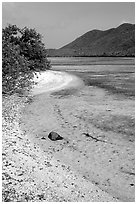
top-left (2, 2), bottom-right (135, 49)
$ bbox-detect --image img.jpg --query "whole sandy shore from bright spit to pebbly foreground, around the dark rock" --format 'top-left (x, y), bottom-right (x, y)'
top-left (3, 71), bottom-right (134, 202)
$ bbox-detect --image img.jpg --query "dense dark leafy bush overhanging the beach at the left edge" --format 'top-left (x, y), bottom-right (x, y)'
top-left (2, 25), bottom-right (50, 93)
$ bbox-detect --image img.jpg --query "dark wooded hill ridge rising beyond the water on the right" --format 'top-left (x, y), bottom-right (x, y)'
top-left (47, 23), bottom-right (135, 57)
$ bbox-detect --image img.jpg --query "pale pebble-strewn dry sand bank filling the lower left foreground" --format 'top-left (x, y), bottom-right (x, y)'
top-left (2, 96), bottom-right (117, 202)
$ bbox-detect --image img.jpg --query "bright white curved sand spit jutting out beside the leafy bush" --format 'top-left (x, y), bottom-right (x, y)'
top-left (32, 71), bottom-right (77, 95)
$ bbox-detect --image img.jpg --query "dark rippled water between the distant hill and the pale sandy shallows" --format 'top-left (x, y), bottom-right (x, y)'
top-left (50, 57), bottom-right (135, 97)
